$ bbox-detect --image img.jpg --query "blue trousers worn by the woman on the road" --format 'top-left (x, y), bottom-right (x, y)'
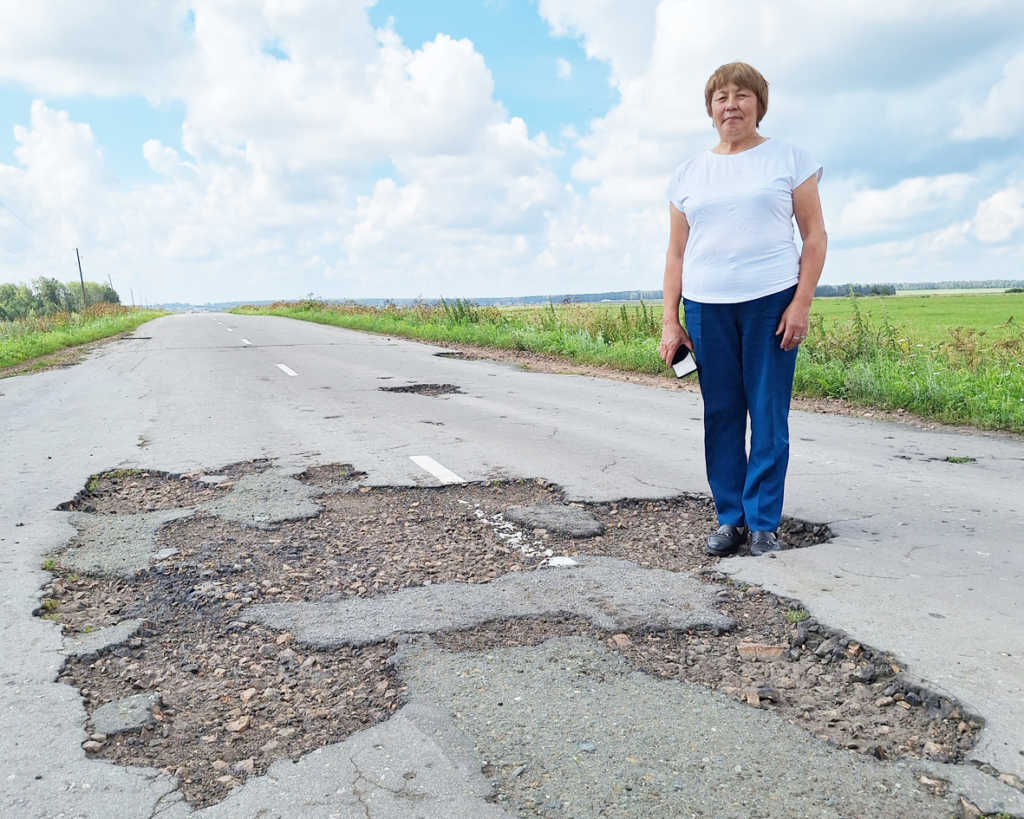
top-left (683, 286), bottom-right (797, 531)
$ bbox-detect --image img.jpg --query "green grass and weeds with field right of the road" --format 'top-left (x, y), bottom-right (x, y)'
top-left (234, 294), bottom-right (1024, 432)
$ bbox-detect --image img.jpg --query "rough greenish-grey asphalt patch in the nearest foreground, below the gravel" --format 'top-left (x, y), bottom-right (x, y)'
top-left (396, 638), bottom-right (983, 819)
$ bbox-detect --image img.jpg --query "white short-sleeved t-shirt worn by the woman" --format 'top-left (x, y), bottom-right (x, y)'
top-left (669, 139), bottom-right (821, 304)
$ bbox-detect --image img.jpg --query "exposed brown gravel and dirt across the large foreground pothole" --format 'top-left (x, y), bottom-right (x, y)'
top-left (39, 462), bottom-right (980, 806)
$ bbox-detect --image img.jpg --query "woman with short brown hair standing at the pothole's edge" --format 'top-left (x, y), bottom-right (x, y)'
top-left (658, 62), bottom-right (826, 556)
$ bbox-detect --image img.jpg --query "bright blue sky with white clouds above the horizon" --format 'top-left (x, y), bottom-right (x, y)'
top-left (0, 0), bottom-right (1024, 304)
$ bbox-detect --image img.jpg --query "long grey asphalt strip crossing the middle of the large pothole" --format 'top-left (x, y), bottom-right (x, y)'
top-left (241, 556), bottom-right (732, 648)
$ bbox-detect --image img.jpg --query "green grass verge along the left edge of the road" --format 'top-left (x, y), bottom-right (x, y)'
top-left (0, 304), bottom-right (164, 370)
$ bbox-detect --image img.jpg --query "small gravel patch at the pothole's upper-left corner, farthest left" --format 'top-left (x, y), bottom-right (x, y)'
top-left (57, 469), bottom-right (230, 515)
